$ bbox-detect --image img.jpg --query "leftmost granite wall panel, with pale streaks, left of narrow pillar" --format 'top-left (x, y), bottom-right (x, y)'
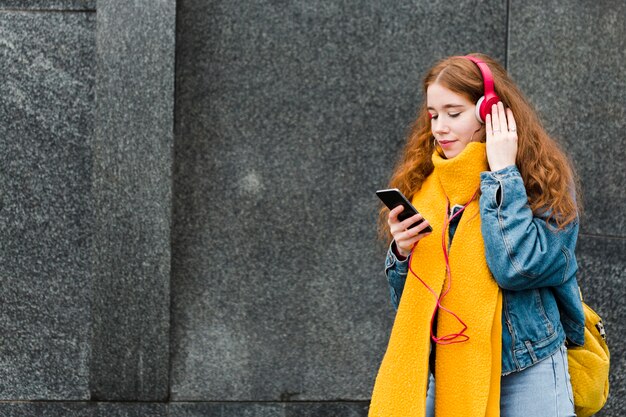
top-left (0, 11), bottom-right (96, 400)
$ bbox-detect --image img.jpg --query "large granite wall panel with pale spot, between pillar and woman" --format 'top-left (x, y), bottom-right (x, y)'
top-left (171, 0), bottom-right (506, 401)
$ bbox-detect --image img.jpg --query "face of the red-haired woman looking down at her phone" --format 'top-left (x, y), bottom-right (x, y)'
top-left (426, 83), bottom-right (483, 159)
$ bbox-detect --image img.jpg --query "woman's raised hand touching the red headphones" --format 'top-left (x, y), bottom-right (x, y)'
top-left (485, 101), bottom-right (517, 171)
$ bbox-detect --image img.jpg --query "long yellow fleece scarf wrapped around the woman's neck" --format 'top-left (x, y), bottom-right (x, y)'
top-left (369, 142), bottom-right (502, 417)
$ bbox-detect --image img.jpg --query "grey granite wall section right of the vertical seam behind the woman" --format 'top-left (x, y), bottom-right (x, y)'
top-left (508, 0), bottom-right (626, 416)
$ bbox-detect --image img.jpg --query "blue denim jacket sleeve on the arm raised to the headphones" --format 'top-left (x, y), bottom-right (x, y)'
top-left (480, 165), bottom-right (578, 291)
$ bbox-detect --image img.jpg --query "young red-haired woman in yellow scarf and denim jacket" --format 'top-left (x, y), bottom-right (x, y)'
top-left (370, 54), bottom-right (584, 417)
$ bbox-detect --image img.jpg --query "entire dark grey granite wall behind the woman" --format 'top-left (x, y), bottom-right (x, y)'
top-left (0, 0), bottom-right (626, 417)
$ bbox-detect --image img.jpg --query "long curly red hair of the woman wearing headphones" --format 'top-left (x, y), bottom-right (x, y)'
top-left (379, 54), bottom-right (580, 239)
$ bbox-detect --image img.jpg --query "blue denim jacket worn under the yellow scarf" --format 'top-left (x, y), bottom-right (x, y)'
top-left (385, 165), bottom-right (585, 375)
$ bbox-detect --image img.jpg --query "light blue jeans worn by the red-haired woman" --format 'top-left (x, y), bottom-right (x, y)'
top-left (426, 346), bottom-right (576, 417)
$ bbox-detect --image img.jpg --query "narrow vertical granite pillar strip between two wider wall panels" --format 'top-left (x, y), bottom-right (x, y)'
top-left (90, 0), bottom-right (176, 401)
